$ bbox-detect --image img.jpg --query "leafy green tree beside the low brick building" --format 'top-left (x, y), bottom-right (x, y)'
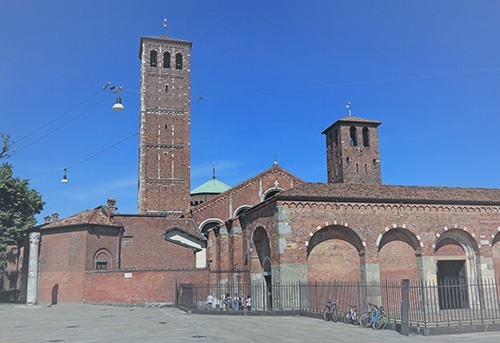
top-left (0, 134), bottom-right (44, 276)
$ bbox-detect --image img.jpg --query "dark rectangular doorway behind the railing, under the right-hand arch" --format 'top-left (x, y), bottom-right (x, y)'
top-left (437, 260), bottom-right (469, 310)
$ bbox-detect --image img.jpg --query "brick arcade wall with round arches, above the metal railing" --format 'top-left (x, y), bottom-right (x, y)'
top-left (237, 196), bottom-right (500, 290)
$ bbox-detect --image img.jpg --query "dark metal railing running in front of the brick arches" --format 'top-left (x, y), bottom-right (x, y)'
top-left (177, 279), bottom-right (500, 328)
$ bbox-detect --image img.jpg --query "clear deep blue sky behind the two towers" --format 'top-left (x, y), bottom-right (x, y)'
top-left (0, 0), bottom-right (500, 221)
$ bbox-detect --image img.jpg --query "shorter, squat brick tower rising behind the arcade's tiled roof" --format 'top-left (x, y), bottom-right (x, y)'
top-left (323, 109), bottom-right (382, 184)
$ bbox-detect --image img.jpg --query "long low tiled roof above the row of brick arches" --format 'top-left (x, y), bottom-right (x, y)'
top-left (277, 183), bottom-right (500, 205)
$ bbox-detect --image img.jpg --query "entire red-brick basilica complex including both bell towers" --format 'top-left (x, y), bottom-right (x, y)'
top-left (4, 33), bottom-right (500, 304)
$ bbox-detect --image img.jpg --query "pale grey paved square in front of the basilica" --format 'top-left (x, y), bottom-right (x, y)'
top-left (0, 304), bottom-right (500, 343)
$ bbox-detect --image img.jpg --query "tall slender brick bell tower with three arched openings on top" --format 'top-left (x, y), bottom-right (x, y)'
top-left (138, 36), bottom-right (192, 217)
